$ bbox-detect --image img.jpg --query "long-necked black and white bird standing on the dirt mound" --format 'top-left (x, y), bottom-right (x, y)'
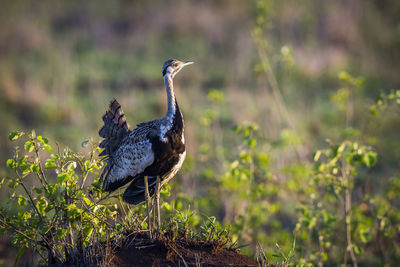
top-left (99, 59), bottom-right (194, 236)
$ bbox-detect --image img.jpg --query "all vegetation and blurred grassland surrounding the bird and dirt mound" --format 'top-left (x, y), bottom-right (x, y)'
top-left (0, 0), bottom-right (400, 266)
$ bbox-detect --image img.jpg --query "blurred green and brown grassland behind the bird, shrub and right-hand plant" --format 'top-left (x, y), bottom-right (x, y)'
top-left (0, 0), bottom-right (400, 266)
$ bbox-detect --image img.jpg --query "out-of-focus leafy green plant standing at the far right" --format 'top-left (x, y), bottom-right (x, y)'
top-left (296, 141), bottom-right (377, 266)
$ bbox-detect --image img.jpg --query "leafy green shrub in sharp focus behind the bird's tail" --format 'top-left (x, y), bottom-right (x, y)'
top-left (0, 131), bottom-right (121, 264)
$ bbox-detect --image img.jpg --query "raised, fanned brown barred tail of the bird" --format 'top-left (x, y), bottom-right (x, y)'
top-left (99, 99), bottom-right (129, 156)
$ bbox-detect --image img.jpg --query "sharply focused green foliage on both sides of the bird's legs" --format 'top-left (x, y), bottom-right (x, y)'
top-left (0, 130), bottom-right (234, 264)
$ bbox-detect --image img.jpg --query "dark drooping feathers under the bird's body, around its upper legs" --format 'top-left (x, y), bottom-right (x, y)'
top-left (122, 176), bottom-right (157, 205)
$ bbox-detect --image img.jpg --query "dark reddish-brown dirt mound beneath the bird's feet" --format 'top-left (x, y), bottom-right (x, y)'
top-left (109, 235), bottom-right (258, 267)
